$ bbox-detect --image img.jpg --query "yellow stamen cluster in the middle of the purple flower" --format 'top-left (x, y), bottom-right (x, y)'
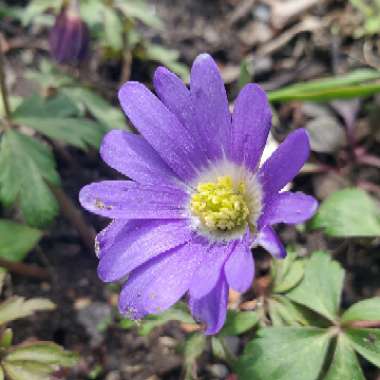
top-left (190, 176), bottom-right (249, 231)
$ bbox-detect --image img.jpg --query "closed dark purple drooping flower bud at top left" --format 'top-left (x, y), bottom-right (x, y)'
top-left (49, 2), bottom-right (89, 64)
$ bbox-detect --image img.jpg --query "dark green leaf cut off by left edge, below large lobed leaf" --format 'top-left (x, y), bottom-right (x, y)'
top-left (0, 219), bottom-right (42, 261)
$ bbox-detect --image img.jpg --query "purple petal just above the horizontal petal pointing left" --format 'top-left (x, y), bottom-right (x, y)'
top-left (100, 129), bottom-right (175, 184)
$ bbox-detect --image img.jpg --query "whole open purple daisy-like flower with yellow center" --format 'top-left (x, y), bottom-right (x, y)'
top-left (80, 54), bottom-right (317, 334)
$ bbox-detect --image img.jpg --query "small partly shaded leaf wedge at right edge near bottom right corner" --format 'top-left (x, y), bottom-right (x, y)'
top-left (346, 329), bottom-right (380, 367)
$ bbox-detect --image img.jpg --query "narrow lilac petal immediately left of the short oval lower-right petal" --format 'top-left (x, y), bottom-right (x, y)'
top-left (189, 242), bottom-right (235, 299)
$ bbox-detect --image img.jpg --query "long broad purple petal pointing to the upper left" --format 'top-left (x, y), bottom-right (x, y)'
top-left (119, 82), bottom-right (204, 180)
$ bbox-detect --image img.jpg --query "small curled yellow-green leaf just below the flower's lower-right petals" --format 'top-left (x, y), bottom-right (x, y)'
top-left (272, 249), bottom-right (304, 293)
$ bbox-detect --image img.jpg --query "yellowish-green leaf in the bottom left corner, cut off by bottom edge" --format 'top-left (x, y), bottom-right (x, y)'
top-left (2, 342), bottom-right (78, 380)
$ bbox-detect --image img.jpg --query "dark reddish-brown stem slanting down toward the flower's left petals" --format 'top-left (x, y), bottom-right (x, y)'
top-left (50, 186), bottom-right (96, 251)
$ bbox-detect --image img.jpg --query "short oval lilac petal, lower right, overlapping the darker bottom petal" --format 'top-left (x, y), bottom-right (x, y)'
top-left (224, 238), bottom-right (255, 293)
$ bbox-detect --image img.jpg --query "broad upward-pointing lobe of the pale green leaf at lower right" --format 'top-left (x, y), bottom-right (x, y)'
top-left (287, 252), bottom-right (344, 321)
